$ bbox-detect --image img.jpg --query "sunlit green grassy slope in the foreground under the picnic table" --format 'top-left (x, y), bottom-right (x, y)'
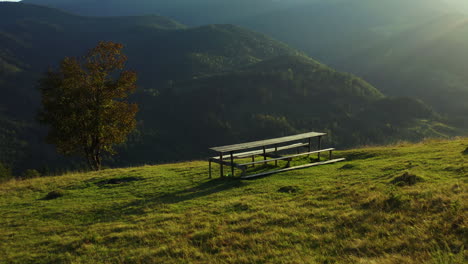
top-left (0, 138), bottom-right (468, 263)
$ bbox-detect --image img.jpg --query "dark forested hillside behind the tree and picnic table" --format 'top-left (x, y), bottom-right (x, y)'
top-left (0, 3), bottom-right (454, 173)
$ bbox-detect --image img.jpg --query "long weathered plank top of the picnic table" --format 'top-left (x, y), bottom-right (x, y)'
top-left (210, 132), bottom-right (327, 153)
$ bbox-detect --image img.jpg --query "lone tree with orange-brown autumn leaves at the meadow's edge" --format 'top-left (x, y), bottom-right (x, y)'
top-left (39, 42), bottom-right (138, 170)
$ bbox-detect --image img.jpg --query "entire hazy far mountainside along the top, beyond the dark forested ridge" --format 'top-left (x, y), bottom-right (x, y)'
top-left (22, 0), bottom-right (468, 128)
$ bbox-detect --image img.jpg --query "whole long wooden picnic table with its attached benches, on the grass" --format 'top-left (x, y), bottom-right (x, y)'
top-left (208, 132), bottom-right (344, 179)
